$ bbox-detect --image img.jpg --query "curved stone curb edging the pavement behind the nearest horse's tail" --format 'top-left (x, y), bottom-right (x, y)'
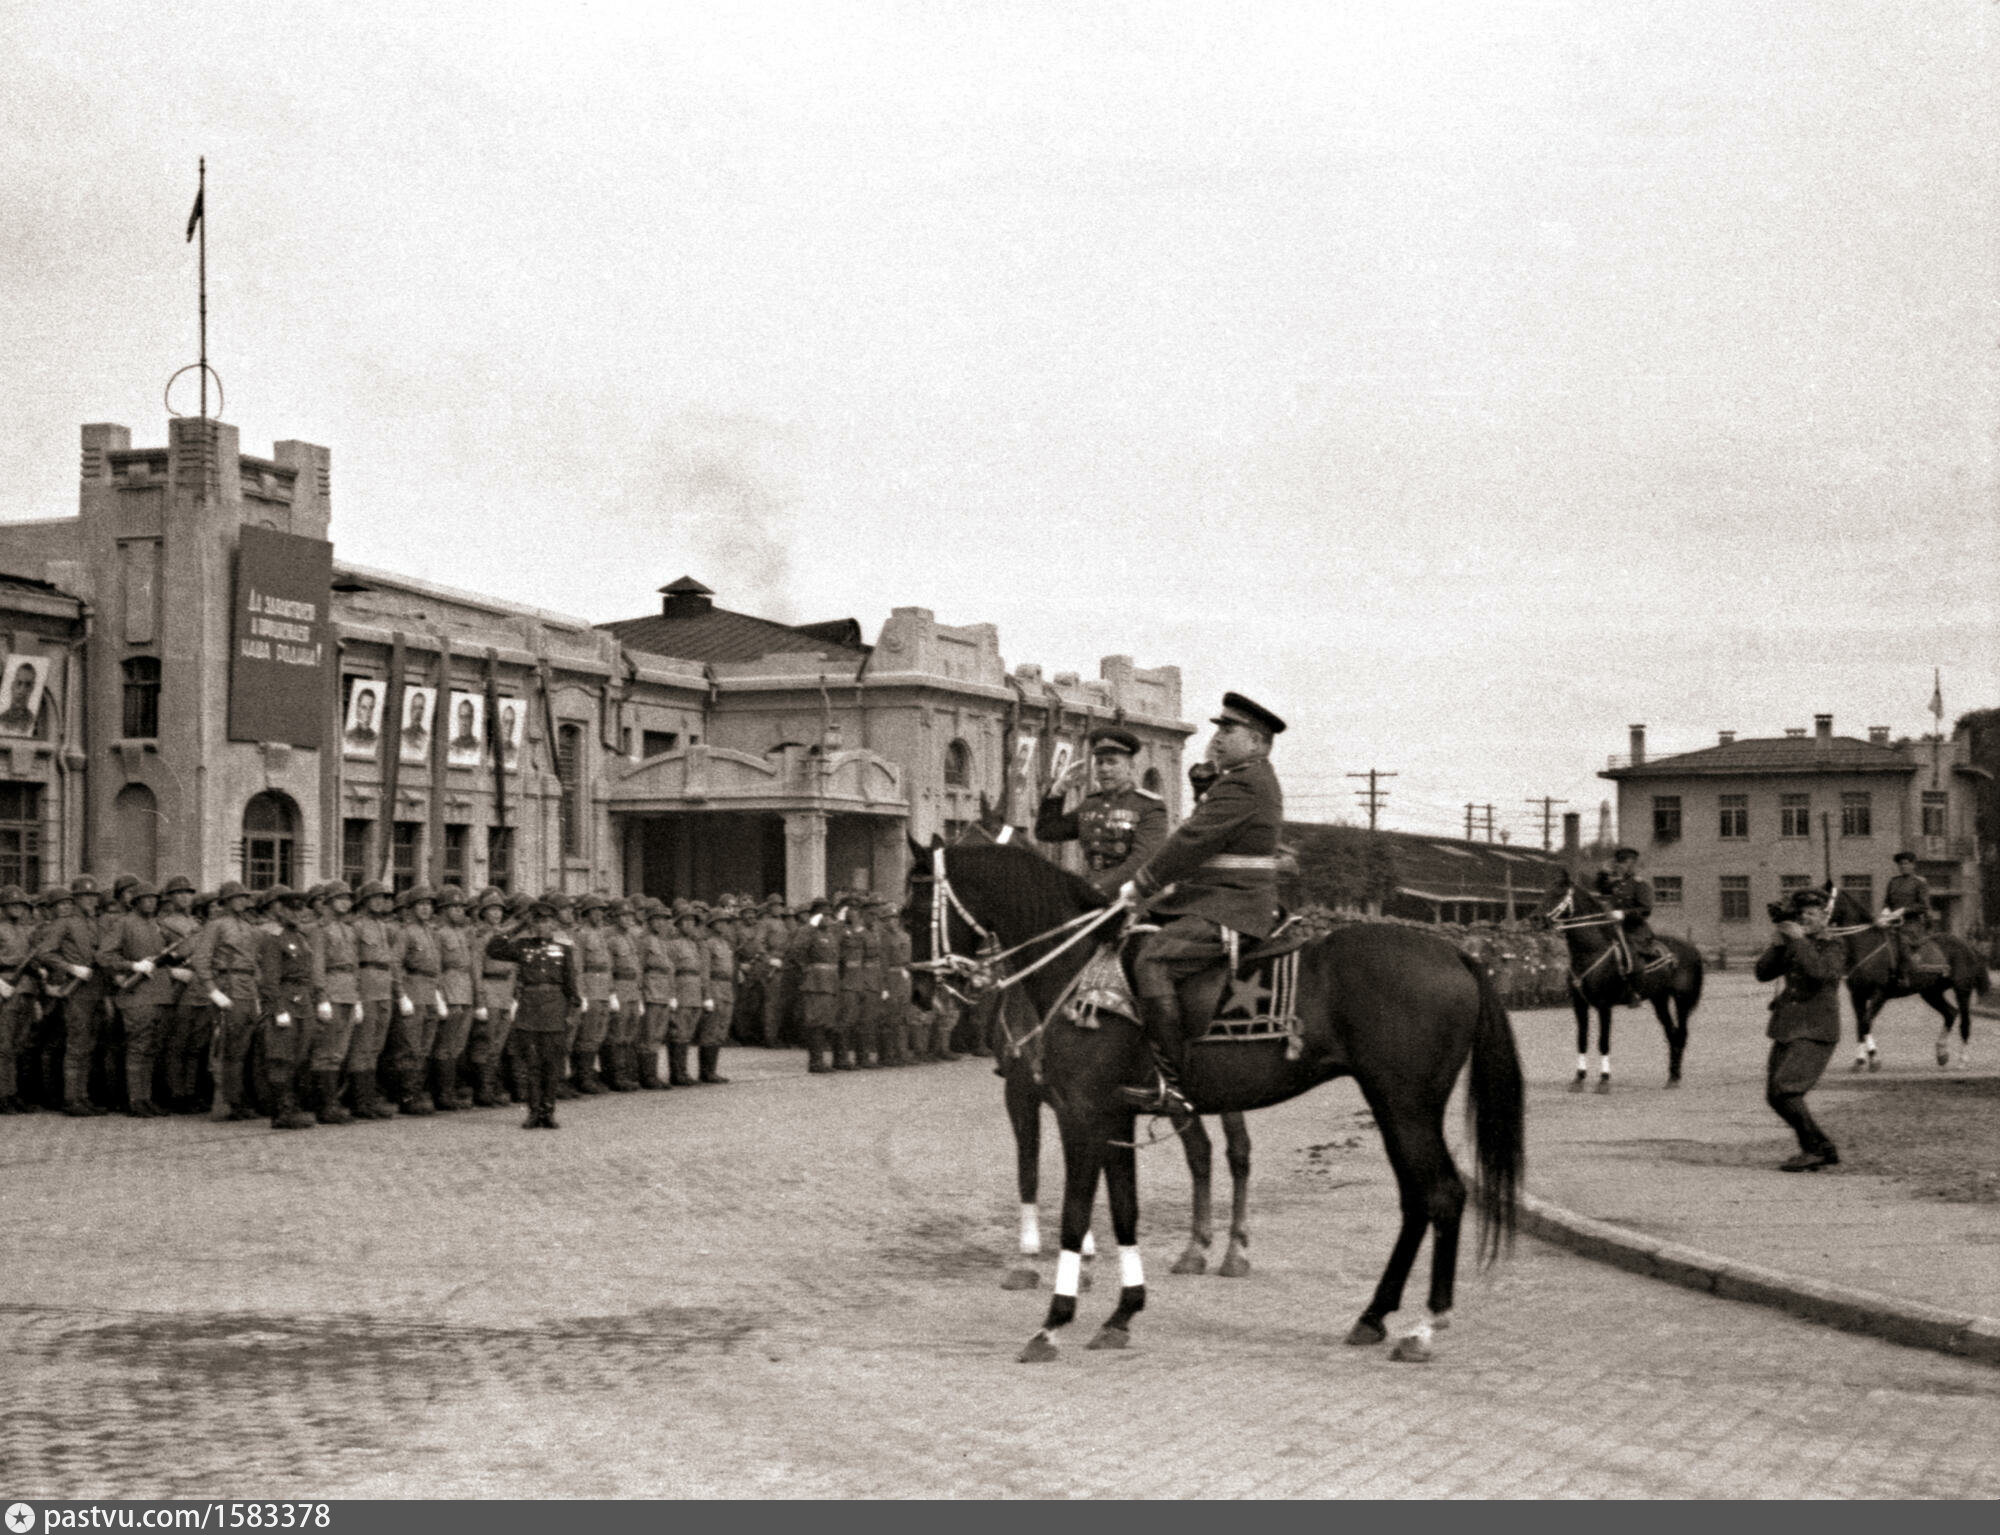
top-left (1518, 1193), bottom-right (2000, 1365)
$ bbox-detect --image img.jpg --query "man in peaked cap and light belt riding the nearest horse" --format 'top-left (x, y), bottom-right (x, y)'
top-left (1118, 694), bottom-right (1284, 1113)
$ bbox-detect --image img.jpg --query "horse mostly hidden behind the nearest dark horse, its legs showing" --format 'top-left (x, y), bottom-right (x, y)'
top-left (948, 815), bottom-right (1250, 1289)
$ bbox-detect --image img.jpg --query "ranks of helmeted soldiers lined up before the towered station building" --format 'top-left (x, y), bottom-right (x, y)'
top-left (0, 875), bottom-right (968, 1129)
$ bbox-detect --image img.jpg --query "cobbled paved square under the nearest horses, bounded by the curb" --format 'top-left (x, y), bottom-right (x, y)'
top-left (0, 1047), bottom-right (2000, 1501)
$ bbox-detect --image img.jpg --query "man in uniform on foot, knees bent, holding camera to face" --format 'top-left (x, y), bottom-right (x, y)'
top-left (1756, 889), bottom-right (1842, 1173)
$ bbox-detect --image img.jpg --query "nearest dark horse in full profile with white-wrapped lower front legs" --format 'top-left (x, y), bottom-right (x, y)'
top-left (904, 845), bottom-right (1524, 1361)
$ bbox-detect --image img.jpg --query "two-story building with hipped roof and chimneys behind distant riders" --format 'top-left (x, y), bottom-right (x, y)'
top-left (1600, 714), bottom-right (1986, 947)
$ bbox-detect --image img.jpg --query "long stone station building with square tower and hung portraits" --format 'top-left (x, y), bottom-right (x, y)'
top-left (0, 418), bottom-right (1192, 901)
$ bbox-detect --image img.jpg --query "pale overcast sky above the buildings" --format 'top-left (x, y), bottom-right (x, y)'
top-left (0, 0), bottom-right (2000, 841)
